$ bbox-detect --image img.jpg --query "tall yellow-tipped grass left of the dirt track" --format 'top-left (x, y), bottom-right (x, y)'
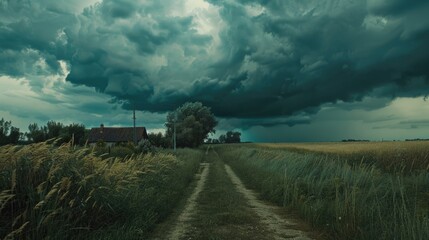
top-left (0, 143), bottom-right (202, 239)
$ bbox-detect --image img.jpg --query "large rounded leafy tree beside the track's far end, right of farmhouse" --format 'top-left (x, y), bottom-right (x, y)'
top-left (165, 102), bottom-right (217, 147)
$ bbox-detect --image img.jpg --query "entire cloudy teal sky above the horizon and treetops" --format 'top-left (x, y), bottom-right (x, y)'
top-left (0, 0), bottom-right (429, 142)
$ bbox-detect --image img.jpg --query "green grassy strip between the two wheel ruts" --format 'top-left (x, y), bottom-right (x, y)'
top-left (184, 151), bottom-right (270, 240)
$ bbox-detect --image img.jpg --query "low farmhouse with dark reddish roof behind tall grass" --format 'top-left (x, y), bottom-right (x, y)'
top-left (88, 124), bottom-right (148, 147)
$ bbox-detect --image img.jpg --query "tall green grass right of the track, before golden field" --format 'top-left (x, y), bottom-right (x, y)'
top-left (217, 145), bottom-right (429, 240)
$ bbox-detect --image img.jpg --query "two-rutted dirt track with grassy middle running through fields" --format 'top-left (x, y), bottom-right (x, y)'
top-left (152, 150), bottom-right (314, 240)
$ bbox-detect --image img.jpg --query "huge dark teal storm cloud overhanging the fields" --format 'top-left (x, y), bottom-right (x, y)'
top-left (0, 0), bottom-right (429, 122)
